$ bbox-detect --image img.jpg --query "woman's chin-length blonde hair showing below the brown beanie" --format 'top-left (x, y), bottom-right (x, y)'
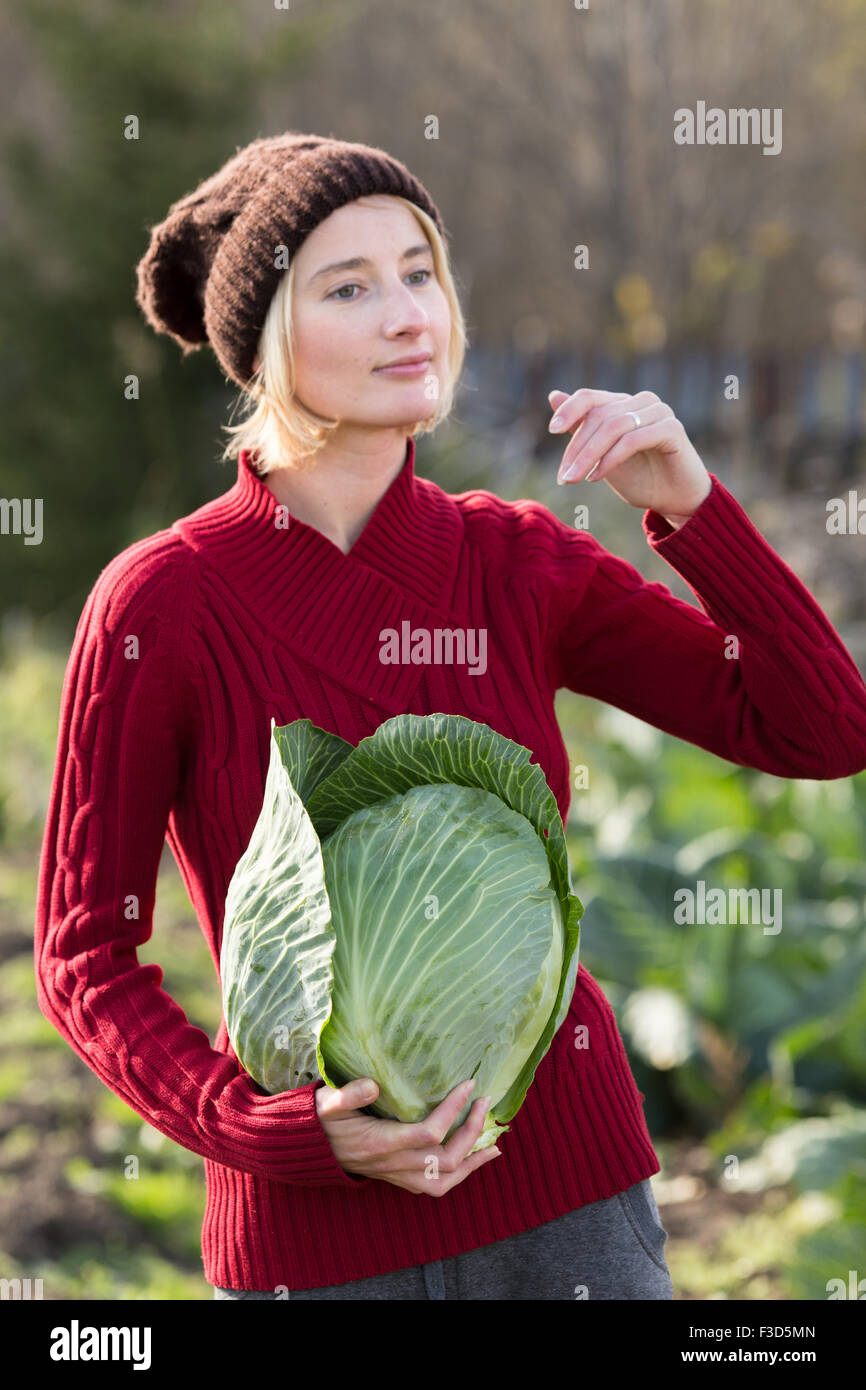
top-left (221, 197), bottom-right (467, 474)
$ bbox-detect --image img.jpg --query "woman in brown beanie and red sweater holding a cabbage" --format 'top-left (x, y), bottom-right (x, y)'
top-left (36, 135), bottom-right (866, 1300)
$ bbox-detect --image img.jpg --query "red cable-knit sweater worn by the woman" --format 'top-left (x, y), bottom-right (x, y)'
top-left (35, 439), bottom-right (866, 1290)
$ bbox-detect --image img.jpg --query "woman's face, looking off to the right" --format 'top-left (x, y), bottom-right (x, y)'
top-left (283, 193), bottom-right (450, 428)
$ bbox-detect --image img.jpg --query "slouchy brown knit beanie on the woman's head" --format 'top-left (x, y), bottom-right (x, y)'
top-left (136, 132), bottom-right (445, 386)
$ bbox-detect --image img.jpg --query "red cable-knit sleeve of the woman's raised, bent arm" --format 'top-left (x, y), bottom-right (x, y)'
top-left (546, 473), bottom-right (866, 780)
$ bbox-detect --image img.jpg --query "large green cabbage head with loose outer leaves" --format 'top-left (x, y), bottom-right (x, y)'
top-left (220, 713), bottom-right (584, 1152)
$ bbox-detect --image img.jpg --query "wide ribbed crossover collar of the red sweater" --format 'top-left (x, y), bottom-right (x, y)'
top-left (171, 436), bottom-right (463, 713)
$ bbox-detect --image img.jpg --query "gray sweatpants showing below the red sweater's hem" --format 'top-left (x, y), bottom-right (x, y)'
top-left (214, 1177), bottom-right (673, 1301)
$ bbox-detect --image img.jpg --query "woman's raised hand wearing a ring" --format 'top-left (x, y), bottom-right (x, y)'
top-left (548, 386), bottom-right (713, 525)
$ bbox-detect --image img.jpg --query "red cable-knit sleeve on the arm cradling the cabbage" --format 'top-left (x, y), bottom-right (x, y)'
top-left (35, 532), bottom-right (370, 1188)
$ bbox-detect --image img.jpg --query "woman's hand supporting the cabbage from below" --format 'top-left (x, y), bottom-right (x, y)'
top-left (316, 1077), bottom-right (502, 1197)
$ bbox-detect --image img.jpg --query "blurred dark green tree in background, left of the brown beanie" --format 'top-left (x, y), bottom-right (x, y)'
top-left (0, 0), bottom-right (322, 627)
